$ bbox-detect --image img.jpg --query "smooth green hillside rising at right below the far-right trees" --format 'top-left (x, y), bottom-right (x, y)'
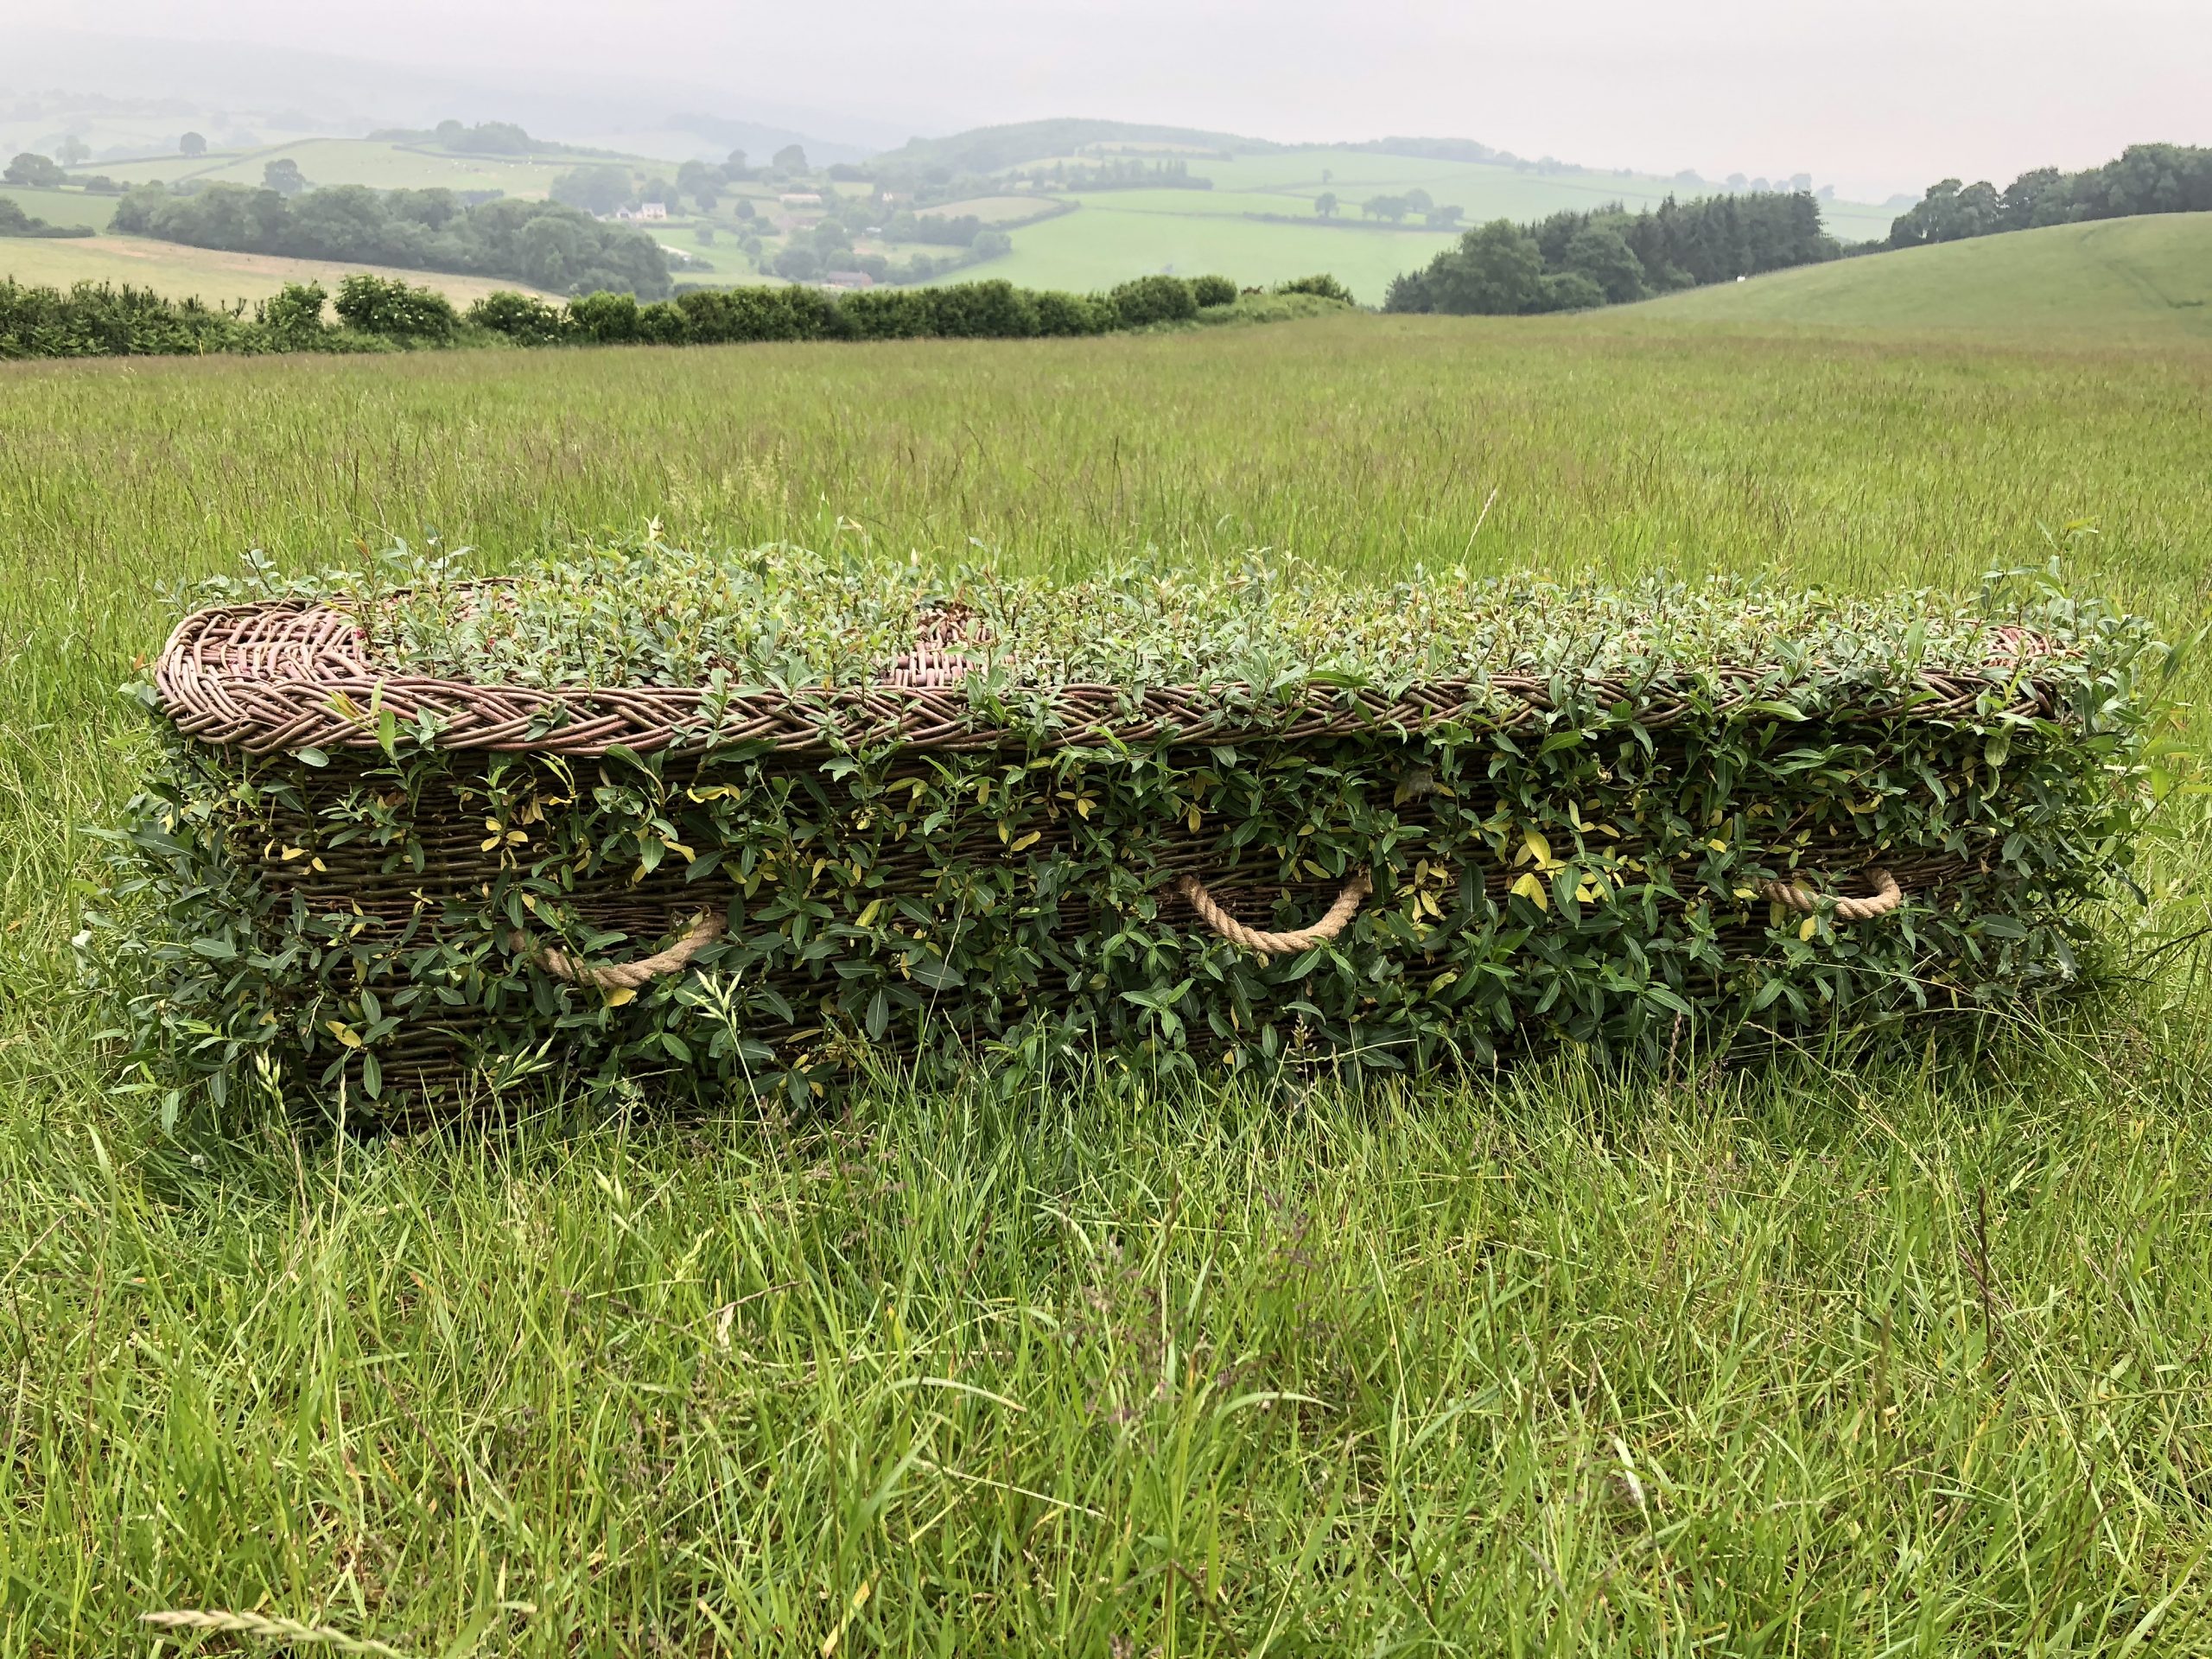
top-left (1630, 213), bottom-right (2212, 340)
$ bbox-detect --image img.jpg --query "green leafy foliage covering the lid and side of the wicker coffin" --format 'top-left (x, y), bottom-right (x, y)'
top-left (86, 544), bottom-right (2164, 1123)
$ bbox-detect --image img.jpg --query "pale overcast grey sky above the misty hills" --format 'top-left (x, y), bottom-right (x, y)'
top-left (0, 0), bottom-right (2212, 199)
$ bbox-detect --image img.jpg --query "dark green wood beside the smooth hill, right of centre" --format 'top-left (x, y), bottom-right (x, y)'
top-left (1382, 190), bottom-right (1842, 316)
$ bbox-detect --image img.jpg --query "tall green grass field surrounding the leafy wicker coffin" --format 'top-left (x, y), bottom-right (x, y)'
top-left (0, 314), bottom-right (2212, 1659)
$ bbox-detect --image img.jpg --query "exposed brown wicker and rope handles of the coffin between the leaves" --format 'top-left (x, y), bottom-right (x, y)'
top-left (155, 583), bottom-right (2088, 1110)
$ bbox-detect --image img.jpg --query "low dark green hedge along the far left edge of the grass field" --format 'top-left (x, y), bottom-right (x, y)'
top-left (0, 272), bottom-right (1351, 359)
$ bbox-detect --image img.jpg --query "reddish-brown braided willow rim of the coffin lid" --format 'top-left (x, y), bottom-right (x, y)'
top-left (155, 600), bottom-right (2059, 759)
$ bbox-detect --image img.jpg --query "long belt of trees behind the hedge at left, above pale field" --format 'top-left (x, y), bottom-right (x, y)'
top-left (113, 183), bottom-right (672, 299)
